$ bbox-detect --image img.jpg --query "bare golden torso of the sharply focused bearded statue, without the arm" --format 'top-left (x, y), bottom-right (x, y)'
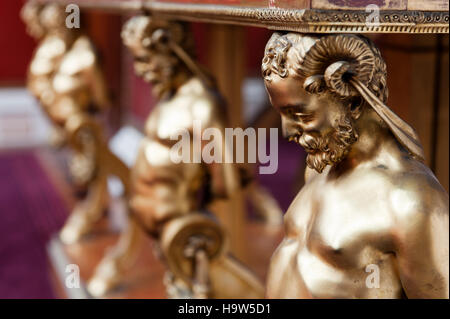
top-left (267, 151), bottom-right (448, 298)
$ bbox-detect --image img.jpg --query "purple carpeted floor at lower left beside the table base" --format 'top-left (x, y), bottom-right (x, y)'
top-left (0, 151), bottom-right (67, 298)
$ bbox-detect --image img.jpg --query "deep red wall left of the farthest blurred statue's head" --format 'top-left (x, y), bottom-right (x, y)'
top-left (0, 0), bottom-right (35, 85)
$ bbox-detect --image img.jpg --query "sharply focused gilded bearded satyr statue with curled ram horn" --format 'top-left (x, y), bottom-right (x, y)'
top-left (262, 33), bottom-right (449, 298)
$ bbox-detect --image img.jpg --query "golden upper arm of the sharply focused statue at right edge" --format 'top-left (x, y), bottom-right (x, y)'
top-left (394, 182), bottom-right (449, 298)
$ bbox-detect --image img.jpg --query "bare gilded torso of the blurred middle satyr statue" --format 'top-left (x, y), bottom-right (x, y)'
top-left (132, 78), bottom-right (222, 222)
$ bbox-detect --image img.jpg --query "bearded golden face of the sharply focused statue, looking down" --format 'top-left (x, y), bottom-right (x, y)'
top-left (266, 74), bottom-right (357, 173)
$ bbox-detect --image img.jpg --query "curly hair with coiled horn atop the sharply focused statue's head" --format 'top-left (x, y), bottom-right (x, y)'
top-left (262, 32), bottom-right (388, 102)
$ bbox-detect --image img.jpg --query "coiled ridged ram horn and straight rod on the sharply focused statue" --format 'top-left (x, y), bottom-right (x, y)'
top-left (300, 35), bottom-right (424, 161)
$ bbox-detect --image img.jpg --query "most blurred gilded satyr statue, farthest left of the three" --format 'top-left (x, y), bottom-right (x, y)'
top-left (22, 1), bottom-right (135, 290)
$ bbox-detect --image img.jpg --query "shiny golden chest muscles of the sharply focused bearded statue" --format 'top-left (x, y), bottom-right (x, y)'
top-left (286, 174), bottom-right (392, 265)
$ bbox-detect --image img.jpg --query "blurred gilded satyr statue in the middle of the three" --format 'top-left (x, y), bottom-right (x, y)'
top-left (115, 16), bottom-right (263, 298)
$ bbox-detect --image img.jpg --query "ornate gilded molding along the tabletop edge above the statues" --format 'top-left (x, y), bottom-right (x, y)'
top-left (36, 0), bottom-right (449, 33)
